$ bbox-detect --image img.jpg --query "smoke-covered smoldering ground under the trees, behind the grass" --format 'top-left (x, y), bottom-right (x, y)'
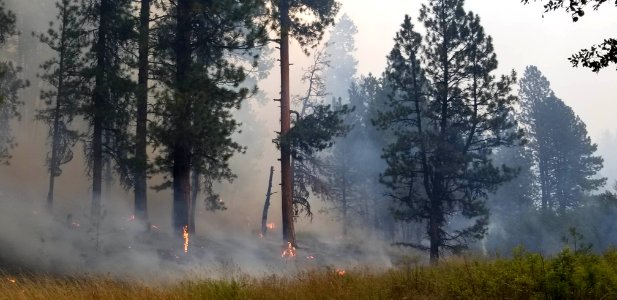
top-left (0, 193), bottom-right (403, 280)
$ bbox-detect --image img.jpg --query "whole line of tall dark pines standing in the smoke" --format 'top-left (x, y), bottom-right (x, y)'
top-left (0, 0), bottom-right (617, 263)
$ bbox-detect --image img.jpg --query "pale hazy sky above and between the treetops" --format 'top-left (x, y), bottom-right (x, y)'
top-left (268, 0), bottom-right (617, 181)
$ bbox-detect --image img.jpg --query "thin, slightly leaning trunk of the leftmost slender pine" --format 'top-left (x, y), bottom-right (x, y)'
top-left (46, 3), bottom-right (68, 212)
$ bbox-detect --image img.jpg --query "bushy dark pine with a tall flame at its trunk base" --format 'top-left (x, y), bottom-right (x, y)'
top-left (152, 0), bottom-right (265, 236)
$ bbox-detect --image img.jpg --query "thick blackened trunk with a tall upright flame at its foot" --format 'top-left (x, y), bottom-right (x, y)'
top-left (172, 0), bottom-right (191, 237)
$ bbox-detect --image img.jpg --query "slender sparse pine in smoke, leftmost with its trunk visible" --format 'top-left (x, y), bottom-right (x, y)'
top-left (37, 0), bottom-right (86, 210)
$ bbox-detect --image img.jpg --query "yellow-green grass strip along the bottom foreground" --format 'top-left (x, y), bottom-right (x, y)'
top-left (0, 249), bottom-right (617, 300)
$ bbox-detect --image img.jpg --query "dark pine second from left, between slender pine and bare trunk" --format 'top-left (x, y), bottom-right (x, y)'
top-left (80, 0), bottom-right (134, 228)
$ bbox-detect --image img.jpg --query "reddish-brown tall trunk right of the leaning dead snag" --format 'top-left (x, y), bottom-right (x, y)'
top-left (279, 0), bottom-right (296, 246)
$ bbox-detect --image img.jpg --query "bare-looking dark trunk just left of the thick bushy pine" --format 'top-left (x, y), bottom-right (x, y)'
top-left (134, 0), bottom-right (150, 223)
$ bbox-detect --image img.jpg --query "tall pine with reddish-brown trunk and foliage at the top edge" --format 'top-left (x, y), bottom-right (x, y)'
top-left (270, 0), bottom-right (339, 245)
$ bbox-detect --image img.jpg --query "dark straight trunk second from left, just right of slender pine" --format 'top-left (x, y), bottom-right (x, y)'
top-left (91, 0), bottom-right (112, 228)
